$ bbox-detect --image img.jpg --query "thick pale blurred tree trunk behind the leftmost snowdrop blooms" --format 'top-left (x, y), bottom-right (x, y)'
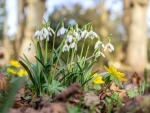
top-left (19, 0), bottom-right (45, 62)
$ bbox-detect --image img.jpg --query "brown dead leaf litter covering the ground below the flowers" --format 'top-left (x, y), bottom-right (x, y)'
top-left (6, 72), bottom-right (150, 113)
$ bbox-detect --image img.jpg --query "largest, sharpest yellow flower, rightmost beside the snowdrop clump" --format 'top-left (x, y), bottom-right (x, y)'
top-left (104, 66), bottom-right (127, 81)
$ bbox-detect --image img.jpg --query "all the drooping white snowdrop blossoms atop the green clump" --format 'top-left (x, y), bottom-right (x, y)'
top-left (31, 22), bottom-right (114, 61)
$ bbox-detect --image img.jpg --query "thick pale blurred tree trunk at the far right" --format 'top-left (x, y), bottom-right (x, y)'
top-left (126, 0), bottom-right (148, 71)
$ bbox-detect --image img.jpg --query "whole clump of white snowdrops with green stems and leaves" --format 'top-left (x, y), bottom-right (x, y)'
top-left (19, 21), bottom-right (114, 96)
